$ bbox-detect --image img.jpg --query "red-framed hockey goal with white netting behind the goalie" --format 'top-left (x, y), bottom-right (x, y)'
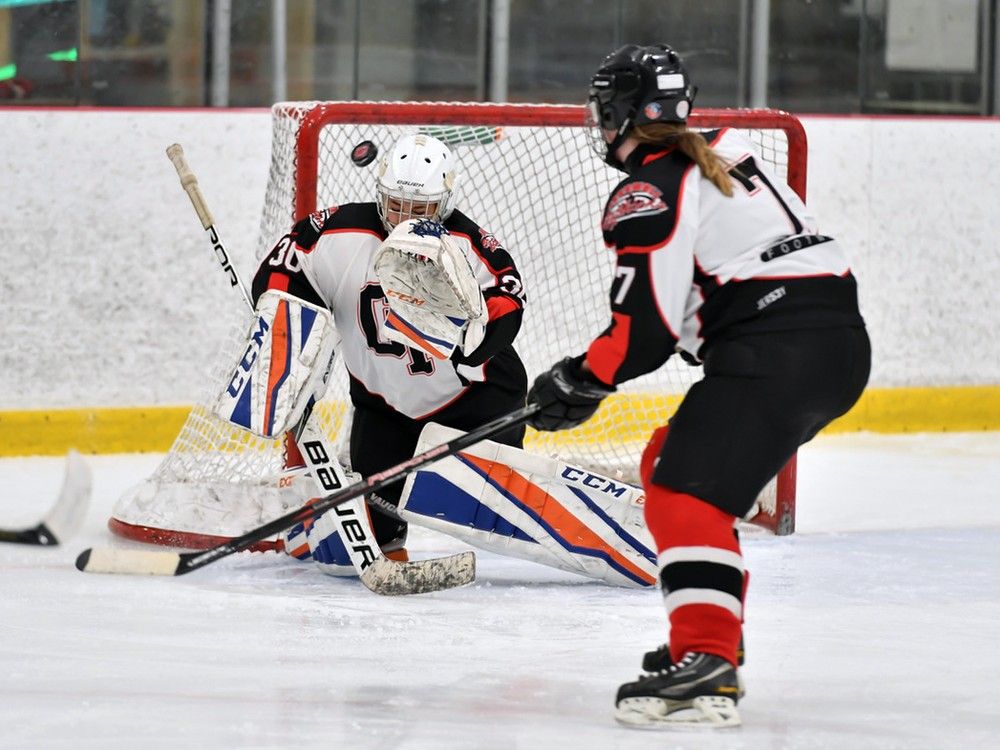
top-left (109, 102), bottom-right (806, 547)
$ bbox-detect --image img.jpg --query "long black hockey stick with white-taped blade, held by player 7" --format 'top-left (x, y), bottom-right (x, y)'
top-left (76, 404), bottom-right (539, 594)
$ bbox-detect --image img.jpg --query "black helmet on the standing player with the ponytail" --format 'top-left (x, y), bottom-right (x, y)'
top-left (588, 44), bottom-right (698, 169)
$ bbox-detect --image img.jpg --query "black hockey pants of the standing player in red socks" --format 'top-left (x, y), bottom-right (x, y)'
top-left (652, 327), bottom-right (871, 516)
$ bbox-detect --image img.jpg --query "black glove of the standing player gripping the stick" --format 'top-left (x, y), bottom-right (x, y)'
top-left (528, 355), bottom-right (616, 432)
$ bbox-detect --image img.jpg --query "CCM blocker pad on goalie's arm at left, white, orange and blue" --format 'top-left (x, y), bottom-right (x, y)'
top-left (215, 289), bottom-right (339, 438)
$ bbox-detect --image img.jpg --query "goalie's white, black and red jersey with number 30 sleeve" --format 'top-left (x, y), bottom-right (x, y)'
top-left (253, 203), bottom-right (525, 419)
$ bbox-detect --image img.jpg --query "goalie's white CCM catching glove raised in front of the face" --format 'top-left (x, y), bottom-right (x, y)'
top-left (374, 219), bottom-right (489, 359)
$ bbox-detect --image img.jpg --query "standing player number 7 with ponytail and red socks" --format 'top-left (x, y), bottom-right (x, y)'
top-left (528, 45), bottom-right (871, 726)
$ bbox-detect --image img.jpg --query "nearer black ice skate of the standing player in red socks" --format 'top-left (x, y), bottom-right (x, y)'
top-left (615, 653), bottom-right (740, 729)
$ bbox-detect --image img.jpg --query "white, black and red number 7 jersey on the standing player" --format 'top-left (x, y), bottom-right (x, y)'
top-left (587, 129), bottom-right (863, 384)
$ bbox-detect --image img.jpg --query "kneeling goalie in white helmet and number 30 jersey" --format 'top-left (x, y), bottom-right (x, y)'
top-left (253, 135), bottom-right (527, 574)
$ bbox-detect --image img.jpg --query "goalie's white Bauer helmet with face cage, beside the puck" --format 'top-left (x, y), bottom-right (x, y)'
top-left (375, 135), bottom-right (458, 232)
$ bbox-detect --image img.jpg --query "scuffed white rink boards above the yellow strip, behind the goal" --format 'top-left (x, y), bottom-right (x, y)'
top-left (0, 108), bottom-right (1000, 409)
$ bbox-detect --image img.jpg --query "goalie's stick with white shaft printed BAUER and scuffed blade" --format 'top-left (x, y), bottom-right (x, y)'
top-left (112, 143), bottom-right (475, 595)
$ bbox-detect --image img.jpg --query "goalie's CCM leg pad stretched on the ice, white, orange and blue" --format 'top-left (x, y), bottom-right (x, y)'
top-left (399, 424), bottom-right (658, 587)
